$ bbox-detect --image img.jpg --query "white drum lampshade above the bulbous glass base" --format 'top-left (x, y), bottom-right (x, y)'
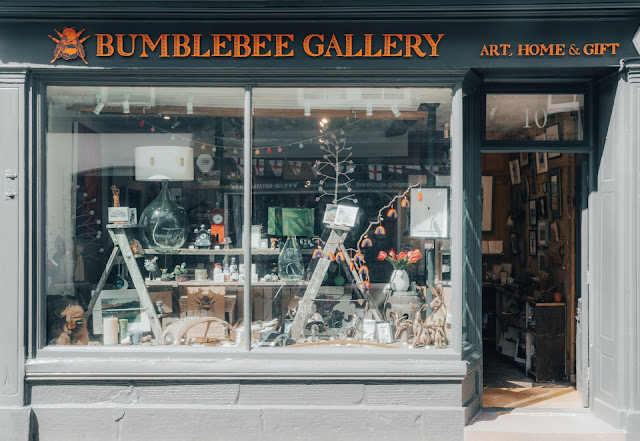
top-left (136, 145), bottom-right (193, 181)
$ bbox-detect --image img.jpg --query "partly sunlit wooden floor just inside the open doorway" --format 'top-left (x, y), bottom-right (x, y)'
top-left (482, 353), bottom-right (582, 409)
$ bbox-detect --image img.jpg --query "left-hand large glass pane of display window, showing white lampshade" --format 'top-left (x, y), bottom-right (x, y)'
top-left (41, 86), bottom-right (244, 346)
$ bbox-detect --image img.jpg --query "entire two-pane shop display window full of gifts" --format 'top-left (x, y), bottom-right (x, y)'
top-left (45, 86), bottom-right (453, 350)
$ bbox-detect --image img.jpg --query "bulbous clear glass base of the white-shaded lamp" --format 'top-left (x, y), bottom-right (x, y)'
top-left (139, 181), bottom-right (189, 249)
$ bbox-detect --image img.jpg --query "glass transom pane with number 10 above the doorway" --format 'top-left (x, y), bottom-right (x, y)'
top-left (485, 94), bottom-right (584, 142)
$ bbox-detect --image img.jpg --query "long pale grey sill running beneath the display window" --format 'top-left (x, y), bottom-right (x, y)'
top-left (26, 346), bottom-right (468, 381)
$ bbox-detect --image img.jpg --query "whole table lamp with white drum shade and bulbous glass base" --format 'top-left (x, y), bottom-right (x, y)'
top-left (135, 146), bottom-right (193, 249)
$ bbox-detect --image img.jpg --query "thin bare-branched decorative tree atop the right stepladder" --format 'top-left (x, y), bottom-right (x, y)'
top-left (316, 133), bottom-right (358, 204)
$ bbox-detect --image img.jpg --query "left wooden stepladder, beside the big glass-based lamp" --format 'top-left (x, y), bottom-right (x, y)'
top-left (85, 224), bottom-right (164, 344)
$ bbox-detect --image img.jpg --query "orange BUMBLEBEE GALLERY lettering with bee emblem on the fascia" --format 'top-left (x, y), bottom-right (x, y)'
top-left (52, 28), bottom-right (445, 62)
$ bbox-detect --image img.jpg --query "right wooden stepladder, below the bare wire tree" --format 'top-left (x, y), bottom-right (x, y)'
top-left (291, 225), bottom-right (382, 340)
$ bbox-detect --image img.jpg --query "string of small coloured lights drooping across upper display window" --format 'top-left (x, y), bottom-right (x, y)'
top-left (131, 115), bottom-right (364, 155)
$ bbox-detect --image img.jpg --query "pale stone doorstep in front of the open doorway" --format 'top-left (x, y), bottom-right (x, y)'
top-left (464, 409), bottom-right (625, 441)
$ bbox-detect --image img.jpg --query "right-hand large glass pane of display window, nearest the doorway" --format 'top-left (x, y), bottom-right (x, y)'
top-left (245, 88), bottom-right (452, 348)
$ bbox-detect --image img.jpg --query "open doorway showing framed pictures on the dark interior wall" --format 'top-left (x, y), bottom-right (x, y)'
top-left (482, 152), bottom-right (583, 409)
